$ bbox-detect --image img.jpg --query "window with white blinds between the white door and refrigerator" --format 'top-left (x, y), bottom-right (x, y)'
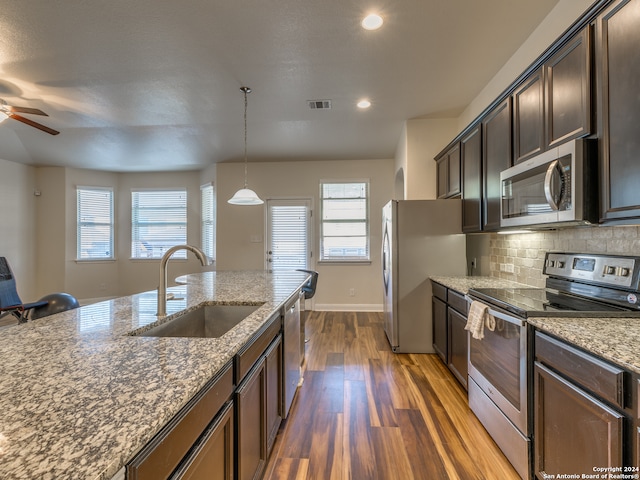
top-left (320, 181), bottom-right (370, 262)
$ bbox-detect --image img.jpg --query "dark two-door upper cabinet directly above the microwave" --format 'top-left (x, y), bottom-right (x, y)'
top-left (512, 27), bottom-right (592, 164)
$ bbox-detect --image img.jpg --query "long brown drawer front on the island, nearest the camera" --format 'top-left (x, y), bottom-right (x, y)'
top-left (127, 364), bottom-right (234, 480)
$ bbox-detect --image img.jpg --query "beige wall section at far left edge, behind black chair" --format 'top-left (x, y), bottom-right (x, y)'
top-left (0, 159), bottom-right (39, 302)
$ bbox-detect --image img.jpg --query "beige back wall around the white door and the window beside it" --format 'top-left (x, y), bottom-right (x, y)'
top-left (217, 159), bottom-right (394, 310)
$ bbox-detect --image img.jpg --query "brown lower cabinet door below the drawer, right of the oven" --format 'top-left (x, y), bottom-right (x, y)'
top-left (534, 362), bottom-right (624, 478)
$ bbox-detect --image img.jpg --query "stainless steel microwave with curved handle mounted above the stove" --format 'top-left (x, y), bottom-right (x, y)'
top-left (500, 138), bottom-right (598, 228)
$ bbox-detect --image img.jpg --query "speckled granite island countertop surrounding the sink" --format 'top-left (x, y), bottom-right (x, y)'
top-left (0, 271), bottom-right (308, 480)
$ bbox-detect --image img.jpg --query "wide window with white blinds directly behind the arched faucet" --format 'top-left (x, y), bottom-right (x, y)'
top-left (131, 190), bottom-right (187, 258)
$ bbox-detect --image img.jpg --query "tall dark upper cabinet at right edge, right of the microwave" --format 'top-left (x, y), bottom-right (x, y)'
top-left (596, 0), bottom-right (640, 221)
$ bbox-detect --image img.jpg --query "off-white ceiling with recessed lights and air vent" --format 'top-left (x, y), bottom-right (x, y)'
top-left (0, 0), bottom-right (558, 171)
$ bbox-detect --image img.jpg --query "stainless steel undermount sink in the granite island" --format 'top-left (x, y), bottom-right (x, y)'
top-left (136, 305), bottom-right (262, 338)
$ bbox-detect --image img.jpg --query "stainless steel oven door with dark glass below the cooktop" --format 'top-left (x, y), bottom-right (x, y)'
top-left (469, 308), bottom-right (529, 437)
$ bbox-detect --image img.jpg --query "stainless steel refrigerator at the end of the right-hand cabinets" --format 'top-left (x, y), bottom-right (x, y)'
top-left (382, 200), bottom-right (467, 353)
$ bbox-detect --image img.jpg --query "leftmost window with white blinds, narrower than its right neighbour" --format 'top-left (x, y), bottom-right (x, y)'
top-left (76, 187), bottom-right (115, 260)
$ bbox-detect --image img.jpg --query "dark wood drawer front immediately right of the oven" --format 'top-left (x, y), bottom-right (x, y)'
top-left (535, 332), bottom-right (624, 408)
